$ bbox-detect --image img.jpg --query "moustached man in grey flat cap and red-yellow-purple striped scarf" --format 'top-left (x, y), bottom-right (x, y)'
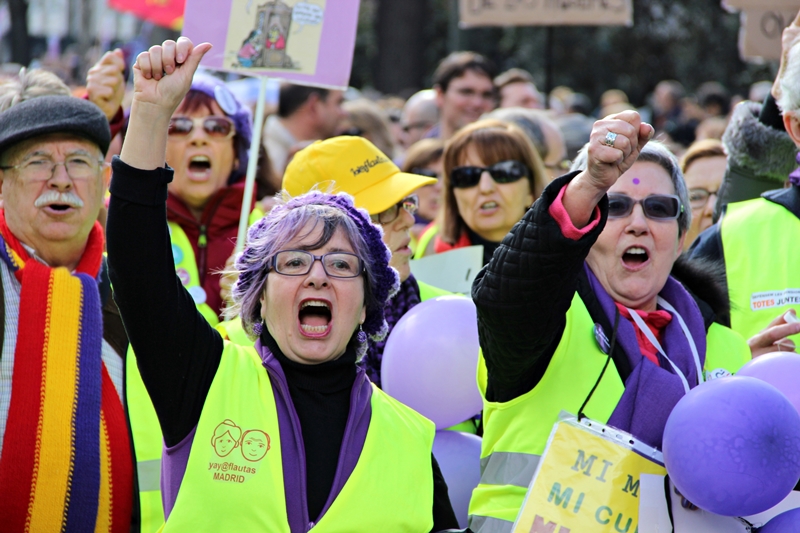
top-left (0, 96), bottom-right (135, 532)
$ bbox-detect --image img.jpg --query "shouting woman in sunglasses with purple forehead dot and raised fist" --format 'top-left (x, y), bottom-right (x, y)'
top-left (470, 111), bottom-right (750, 532)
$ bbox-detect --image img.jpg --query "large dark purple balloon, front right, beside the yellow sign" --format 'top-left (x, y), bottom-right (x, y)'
top-left (663, 376), bottom-right (800, 516)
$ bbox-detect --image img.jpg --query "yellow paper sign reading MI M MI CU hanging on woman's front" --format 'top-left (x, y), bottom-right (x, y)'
top-left (513, 419), bottom-right (666, 533)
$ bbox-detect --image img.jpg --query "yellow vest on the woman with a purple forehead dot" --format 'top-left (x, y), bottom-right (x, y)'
top-left (469, 293), bottom-right (750, 533)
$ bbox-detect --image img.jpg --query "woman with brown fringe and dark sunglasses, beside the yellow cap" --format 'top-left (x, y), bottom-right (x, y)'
top-left (416, 120), bottom-right (547, 264)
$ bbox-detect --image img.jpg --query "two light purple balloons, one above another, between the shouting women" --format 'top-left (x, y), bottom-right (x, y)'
top-left (381, 296), bottom-right (483, 528)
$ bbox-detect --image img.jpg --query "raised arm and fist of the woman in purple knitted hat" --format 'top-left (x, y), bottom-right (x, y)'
top-left (107, 38), bottom-right (222, 446)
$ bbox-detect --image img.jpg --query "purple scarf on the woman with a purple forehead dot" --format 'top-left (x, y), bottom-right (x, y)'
top-left (584, 264), bottom-right (706, 449)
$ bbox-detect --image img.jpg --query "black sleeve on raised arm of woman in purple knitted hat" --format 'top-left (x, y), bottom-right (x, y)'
top-left (106, 157), bottom-right (222, 446)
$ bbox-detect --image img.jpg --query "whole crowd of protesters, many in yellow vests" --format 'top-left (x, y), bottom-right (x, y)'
top-left (0, 10), bottom-right (800, 533)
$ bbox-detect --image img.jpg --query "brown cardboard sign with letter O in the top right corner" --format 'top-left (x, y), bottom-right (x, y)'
top-left (739, 9), bottom-right (800, 60)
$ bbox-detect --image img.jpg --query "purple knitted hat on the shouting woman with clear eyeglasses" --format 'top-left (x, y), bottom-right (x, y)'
top-left (234, 191), bottom-right (400, 341)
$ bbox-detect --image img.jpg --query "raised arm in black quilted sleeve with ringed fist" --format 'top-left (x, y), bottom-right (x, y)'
top-left (472, 112), bottom-right (653, 402)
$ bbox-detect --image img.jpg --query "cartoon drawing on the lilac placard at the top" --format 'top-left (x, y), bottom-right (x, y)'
top-left (225, 0), bottom-right (326, 75)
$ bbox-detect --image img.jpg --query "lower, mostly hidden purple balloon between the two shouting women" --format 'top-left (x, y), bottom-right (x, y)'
top-left (433, 429), bottom-right (481, 528)
